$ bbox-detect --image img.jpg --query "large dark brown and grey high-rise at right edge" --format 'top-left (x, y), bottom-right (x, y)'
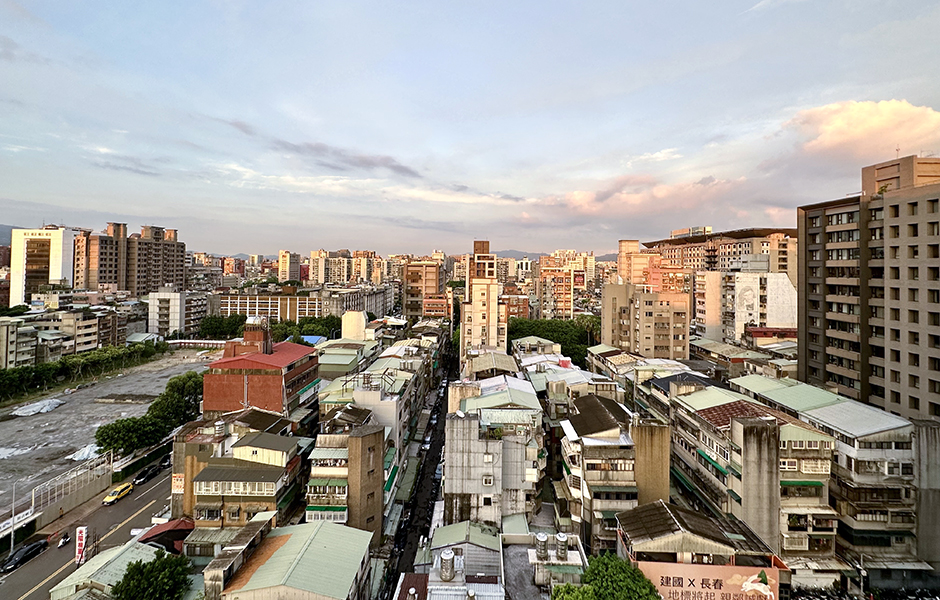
top-left (798, 156), bottom-right (940, 418)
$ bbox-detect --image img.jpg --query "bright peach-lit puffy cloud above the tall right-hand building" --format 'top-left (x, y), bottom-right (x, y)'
top-left (784, 100), bottom-right (940, 162)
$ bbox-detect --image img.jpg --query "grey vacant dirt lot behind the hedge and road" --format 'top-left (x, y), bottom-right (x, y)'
top-left (0, 350), bottom-right (221, 507)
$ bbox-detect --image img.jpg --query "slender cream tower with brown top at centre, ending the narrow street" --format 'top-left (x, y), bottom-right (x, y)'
top-left (460, 241), bottom-right (508, 360)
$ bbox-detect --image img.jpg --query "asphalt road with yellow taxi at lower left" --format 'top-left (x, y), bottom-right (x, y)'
top-left (0, 471), bottom-right (170, 600)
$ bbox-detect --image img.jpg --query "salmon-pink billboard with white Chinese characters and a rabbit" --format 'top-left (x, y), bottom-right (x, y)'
top-left (637, 561), bottom-right (780, 600)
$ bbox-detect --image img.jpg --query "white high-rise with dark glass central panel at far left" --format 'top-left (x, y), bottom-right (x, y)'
top-left (10, 225), bottom-right (79, 306)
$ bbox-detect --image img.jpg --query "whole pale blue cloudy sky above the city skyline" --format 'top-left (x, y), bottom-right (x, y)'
top-left (0, 0), bottom-right (940, 254)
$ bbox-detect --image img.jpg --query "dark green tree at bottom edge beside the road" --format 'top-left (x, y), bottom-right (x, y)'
top-left (111, 550), bottom-right (189, 600)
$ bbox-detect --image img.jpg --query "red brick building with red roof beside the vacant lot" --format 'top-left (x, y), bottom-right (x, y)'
top-left (202, 317), bottom-right (319, 422)
